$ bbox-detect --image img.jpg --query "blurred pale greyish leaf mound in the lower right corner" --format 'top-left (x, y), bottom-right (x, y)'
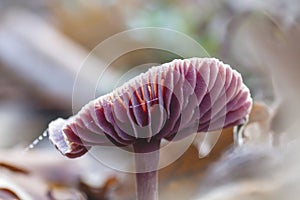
top-left (195, 141), bottom-right (300, 200)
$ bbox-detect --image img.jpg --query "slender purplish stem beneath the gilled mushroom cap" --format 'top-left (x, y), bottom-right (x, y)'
top-left (133, 139), bottom-right (160, 200)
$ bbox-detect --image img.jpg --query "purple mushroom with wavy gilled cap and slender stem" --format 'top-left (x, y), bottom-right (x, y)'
top-left (48, 58), bottom-right (252, 200)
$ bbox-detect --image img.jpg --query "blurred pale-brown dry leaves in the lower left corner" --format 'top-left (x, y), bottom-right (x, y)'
top-left (0, 149), bottom-right (119, 200)
